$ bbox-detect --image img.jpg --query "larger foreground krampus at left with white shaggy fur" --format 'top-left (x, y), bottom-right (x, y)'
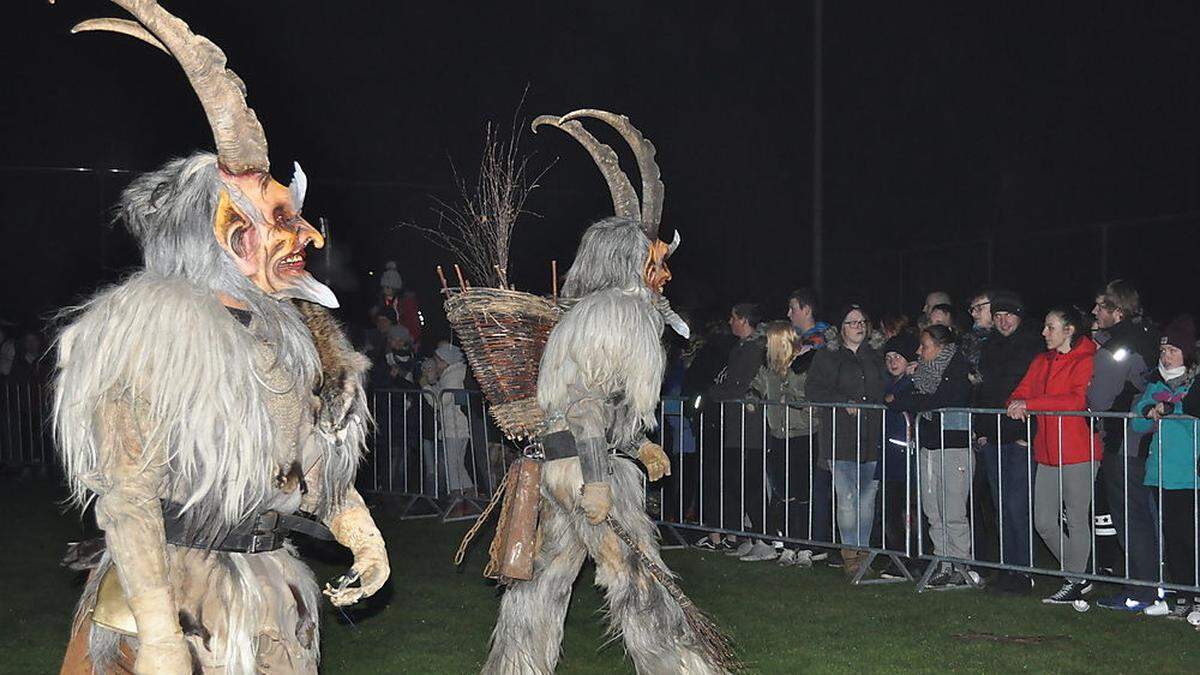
top-left (54, 0), bottom-right (389, 675)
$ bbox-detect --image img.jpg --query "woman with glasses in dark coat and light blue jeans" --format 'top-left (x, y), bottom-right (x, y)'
top-left (808, 305), bottom-right (886, 579)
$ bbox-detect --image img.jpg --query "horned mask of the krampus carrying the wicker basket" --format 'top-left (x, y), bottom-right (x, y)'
top-left (533, 108), bottom-right (680, 294)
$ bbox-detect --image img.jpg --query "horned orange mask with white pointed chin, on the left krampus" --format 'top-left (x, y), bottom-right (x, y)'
top-left (71, 0), bottom-right (337, 307)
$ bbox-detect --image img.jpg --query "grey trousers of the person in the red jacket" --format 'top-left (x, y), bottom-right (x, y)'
top-left (1033, 461), bottom-right (1096, 572)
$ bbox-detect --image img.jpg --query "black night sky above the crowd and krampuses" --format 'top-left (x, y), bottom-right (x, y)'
top-left (0, 0), bottom-right (1200, 336)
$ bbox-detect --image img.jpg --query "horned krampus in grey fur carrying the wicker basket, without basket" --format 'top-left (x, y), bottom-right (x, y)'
top-left (484, 110), bottom-right (725, 675)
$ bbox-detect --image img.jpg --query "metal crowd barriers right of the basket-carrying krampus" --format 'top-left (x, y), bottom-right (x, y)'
top-left (652, 398), bottom-right (1200, 595)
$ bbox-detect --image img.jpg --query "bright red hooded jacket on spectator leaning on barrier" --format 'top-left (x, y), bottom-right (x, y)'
top-left (1006, 338), bottom-right (1104, 466)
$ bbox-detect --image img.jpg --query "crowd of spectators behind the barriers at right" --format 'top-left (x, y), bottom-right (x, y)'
top-left (664, 280), bottom-right (1200, 619)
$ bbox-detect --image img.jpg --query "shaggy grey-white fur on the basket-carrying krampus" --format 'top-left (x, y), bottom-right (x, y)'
top-left (484, 217), bottom-right (721, 675)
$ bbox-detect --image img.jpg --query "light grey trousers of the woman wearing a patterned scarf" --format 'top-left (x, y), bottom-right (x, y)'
top-left (917, 448), bottom-right (974, 558)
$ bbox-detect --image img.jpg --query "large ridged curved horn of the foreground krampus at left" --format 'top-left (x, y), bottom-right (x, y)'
top-left (72, 0), bottom-right (270, 174)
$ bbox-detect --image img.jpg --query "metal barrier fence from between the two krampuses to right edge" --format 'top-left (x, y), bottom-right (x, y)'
top-left (362, 390), bottom-right (1200, 595)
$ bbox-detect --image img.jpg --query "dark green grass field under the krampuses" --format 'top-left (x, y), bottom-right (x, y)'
top-left (0, 479), bottom-right (1200, 674)
